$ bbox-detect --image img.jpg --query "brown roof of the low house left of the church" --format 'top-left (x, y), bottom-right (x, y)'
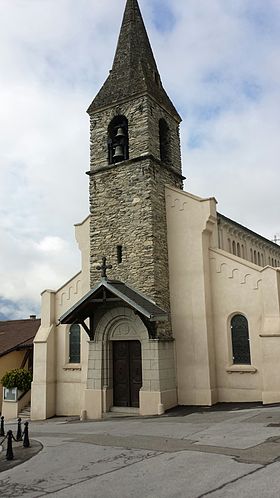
top-left (0, 318), bottom-right (41, 357)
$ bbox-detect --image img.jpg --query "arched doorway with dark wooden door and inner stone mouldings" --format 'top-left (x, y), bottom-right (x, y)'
top-left (93, 307), bottom-right (149, 412)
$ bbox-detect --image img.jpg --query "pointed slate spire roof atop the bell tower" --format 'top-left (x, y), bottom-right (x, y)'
top-left (88, 0), bottom-right (180, 120)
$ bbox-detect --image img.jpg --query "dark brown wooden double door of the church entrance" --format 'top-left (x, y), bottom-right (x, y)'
top-left (113, 341), bottom-right (142, 408)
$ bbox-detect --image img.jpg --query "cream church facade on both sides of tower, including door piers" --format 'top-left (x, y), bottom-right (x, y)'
top-left (32, 187), bottom-right (280, 419)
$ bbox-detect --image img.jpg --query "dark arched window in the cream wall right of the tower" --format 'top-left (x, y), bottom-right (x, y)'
top-left (230, 315), bottom-right (251, 365)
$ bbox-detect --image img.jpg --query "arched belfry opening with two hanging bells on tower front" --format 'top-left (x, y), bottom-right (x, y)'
top-left (108, 116), bottom-right (129, 164)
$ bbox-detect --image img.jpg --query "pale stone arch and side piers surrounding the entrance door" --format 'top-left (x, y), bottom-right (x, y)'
top-left (84, 306), bottom-right (177, 418)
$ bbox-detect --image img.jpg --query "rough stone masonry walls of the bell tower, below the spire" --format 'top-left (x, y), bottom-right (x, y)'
top-left (90, 97), bottom-right (181, 334)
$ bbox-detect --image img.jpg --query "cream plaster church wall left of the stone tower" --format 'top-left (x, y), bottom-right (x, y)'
top-left (31, 217), bottom-right (89, 419)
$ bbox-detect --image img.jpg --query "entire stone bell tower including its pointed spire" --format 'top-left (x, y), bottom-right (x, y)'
top-left (87, 0), bottom-right (183, 335)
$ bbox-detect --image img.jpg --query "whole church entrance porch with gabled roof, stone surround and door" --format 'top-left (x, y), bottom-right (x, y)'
top-left (60, 277), bottom-right (177, 419)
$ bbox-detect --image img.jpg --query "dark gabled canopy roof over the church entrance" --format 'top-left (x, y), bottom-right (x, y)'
top-left (59, 278), bottom-right (168, 324)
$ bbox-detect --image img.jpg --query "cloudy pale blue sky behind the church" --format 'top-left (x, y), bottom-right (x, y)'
top-left (0, 0), bottom-right (280, 319)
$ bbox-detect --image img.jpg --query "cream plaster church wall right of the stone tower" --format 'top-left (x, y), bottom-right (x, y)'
top-left (166, 188), bottom-right (280, 405)
